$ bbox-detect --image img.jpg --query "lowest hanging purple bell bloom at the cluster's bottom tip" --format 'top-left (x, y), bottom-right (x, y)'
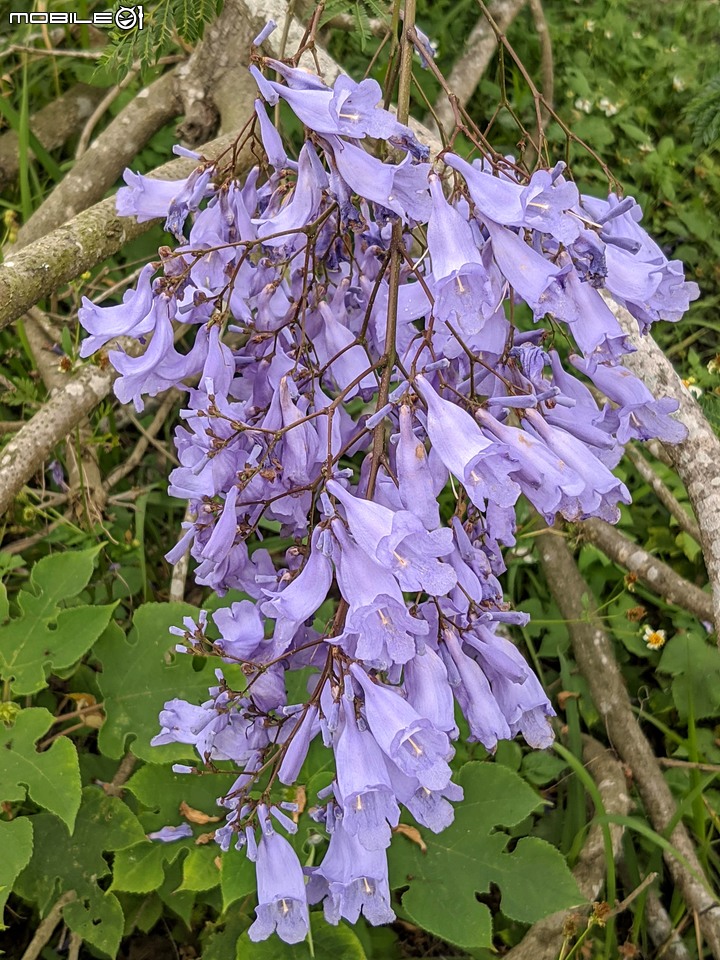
top-left (248, 823), bottom-right (310, 943)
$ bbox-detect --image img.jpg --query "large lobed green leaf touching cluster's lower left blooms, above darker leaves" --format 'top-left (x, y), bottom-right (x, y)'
top-left (94, 603), bottom-right (211, 760)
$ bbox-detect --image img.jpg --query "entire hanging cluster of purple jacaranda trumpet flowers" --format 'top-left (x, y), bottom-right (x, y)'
top-left (80, 39), bottom-right (697, 943)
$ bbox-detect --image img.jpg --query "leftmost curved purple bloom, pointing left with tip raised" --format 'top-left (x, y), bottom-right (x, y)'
top-left (78, 263), bottom-right (157, 357)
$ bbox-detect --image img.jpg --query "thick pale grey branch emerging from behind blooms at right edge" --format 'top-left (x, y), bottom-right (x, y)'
top-left (606, 298), bottom-right (720, 627)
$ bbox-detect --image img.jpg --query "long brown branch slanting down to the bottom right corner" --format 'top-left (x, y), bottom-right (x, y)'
top-left (538, 531), bottom-right (720, 960)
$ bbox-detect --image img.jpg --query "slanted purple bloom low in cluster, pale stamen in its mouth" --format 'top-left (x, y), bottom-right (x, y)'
top-left (350, 664), bottom-right (452, 790)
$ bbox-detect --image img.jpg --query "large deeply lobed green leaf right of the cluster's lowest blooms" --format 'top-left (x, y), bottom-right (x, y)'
top-left (390, 763), bottom-right (582, 949)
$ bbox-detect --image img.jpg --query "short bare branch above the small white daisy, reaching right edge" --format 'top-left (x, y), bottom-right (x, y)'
top-left (579, 517), bottom-right (713, 623)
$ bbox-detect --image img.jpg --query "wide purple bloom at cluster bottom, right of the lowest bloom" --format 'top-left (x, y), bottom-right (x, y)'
top-left (307, 822), bottom-right (395, 926)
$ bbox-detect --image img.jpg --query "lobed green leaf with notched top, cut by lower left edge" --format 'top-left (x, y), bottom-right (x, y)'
top-left (0, 707), bottom-right (81, 830)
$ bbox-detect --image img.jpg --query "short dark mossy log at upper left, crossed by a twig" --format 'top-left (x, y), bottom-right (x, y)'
top-left (0, 83), bottom-right (106, 190)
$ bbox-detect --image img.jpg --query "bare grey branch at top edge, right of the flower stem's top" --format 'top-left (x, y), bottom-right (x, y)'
top-left (425, 0), bottom-right (527, 130)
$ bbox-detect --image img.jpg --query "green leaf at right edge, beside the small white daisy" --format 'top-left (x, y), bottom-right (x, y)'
top-left (658, 630), bottom-right (720, 721)
